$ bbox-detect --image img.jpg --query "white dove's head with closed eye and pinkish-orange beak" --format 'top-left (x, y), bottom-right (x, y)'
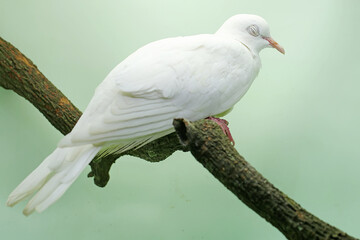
top-left (216, 14), bottom-right (285, 54)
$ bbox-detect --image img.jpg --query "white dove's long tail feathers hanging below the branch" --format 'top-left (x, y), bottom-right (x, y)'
top-left (7, 144), bottom-right (101, 215)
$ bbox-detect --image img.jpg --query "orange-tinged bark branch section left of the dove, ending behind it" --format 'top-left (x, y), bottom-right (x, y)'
top-left (0, 37), bottom-right (81, 134)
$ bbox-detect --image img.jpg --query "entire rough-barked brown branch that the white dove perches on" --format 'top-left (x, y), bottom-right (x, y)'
top-left (0, 38), bottom-right (355, 240)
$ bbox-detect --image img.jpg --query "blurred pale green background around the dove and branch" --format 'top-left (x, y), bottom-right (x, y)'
top-left (0, 0), bottom-right (360, 240)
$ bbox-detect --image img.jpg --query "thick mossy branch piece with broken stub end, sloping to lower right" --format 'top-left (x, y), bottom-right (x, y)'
top-left (174, 119), bottom-right (355, 240)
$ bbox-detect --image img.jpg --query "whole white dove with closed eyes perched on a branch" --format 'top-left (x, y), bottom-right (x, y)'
top-left (7, 14), bottom-right (285, 216)
